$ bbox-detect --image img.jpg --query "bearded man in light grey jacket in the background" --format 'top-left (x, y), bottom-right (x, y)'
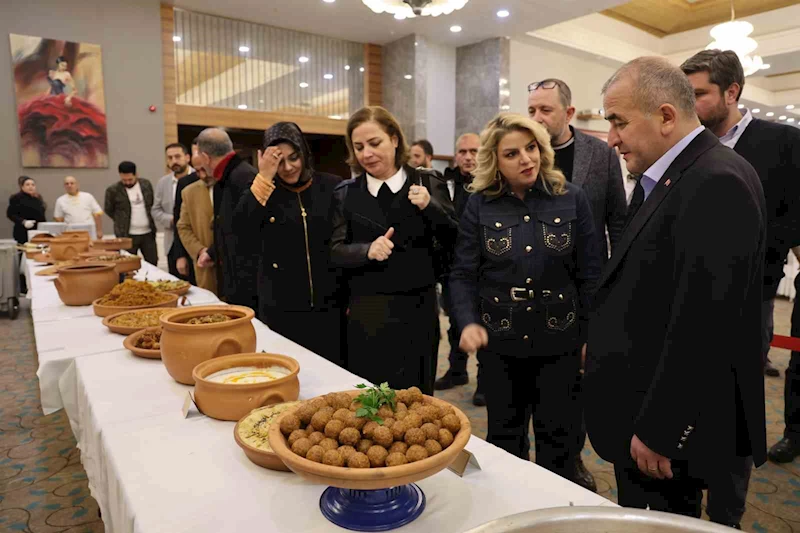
top-left (150, 143), bottom-right (194, 279)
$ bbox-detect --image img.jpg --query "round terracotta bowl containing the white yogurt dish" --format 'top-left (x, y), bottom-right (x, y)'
top-left (192, 353), bottom-right (300, 421)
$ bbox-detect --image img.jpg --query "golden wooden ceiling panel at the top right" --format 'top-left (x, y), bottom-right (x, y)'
top-left (601, 0), bottom-right (798, 37)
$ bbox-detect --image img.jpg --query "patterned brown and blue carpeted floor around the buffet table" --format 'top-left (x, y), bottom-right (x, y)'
top-left (0, 300), bottom-right (800, 533)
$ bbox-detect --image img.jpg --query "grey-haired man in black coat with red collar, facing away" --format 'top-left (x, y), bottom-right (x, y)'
top-left (196, 128), bottom-right (259, 310)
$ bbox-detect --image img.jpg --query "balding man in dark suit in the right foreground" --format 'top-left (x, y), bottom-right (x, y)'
top-left (584, 57), bottom-right (766, 517)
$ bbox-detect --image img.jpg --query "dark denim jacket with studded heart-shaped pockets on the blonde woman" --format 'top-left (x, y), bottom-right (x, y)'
top-left (450, 180), bottom-right (602, 357)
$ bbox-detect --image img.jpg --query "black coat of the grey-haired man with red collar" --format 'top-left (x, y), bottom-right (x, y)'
top-left (208, 155), bottom-right (259, 310)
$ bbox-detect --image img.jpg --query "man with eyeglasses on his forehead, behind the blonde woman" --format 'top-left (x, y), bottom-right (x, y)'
top-left (528, 78), bottom-right (628, 491)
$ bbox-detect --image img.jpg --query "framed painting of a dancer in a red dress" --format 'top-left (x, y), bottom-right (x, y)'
top-left (10, 34), bottom-right (108, 168)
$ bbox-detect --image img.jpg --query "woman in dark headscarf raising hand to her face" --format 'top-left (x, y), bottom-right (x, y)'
top-left (234, 122), bottom-right (344, 366)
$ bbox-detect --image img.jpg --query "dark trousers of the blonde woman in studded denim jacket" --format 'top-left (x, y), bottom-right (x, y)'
top-left (481, 350), bottom-right (580, 481)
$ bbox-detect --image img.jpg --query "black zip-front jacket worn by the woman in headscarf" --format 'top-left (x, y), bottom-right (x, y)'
top-left (234, 172), bottom-right (341, 316)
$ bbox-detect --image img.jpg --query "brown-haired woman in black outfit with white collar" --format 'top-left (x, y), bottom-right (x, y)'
top-left (331, 107), bottom-right (456, 394)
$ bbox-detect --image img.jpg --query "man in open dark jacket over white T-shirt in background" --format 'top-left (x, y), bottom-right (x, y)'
top-left (105, 161), bottom-right (158, 265)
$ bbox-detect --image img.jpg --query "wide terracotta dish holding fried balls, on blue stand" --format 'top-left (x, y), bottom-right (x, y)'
top-left (269, 390), bottom-right (472, 490)
